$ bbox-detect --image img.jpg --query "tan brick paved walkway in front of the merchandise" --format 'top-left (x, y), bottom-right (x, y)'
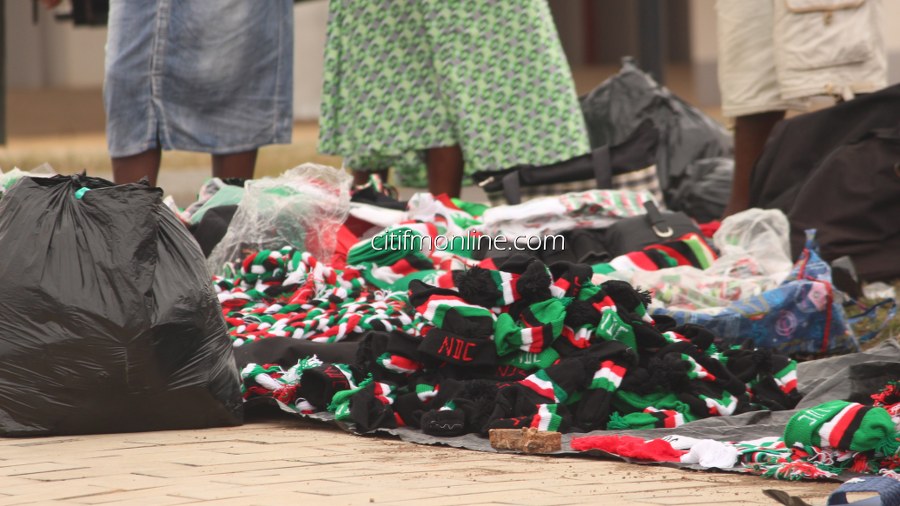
top-left (0, 419), bottom-right (836, 506)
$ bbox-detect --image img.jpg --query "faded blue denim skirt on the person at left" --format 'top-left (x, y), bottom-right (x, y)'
top-left (103, 0), bottom-right (293, 157)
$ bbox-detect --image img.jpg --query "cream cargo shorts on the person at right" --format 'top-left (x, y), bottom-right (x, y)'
top-left (716, 0), bottom-right (887, 118)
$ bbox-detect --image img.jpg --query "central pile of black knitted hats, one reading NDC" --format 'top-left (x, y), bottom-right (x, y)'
top-left (243, 257), bottom-right (799, 436)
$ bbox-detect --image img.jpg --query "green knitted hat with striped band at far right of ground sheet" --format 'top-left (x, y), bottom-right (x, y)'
top-left (784, 401), bottom-right (900, 455)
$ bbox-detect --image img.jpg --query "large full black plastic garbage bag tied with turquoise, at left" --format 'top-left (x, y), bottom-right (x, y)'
top-left (0, 176), bottom-right (243, 436)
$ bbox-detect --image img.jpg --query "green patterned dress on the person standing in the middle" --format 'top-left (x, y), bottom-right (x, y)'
top-left (319, 0), bottom-right (590, 186)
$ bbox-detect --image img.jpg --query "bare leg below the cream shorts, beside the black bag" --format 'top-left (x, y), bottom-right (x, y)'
top-left (722, 111), bottom-right (784, 218)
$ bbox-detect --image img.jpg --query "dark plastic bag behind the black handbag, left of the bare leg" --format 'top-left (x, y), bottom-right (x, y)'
top-left (579, 58), bottom-right (733, 210)
